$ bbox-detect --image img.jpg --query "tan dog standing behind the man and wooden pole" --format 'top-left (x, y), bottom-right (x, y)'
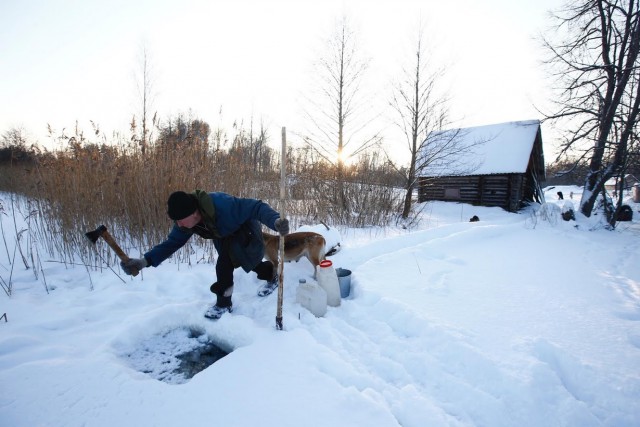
top-left (262, 231), bottom-right (326, 278)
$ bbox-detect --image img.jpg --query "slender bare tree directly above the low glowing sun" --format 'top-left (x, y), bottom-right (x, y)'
top-left (303, 17), bottom-right (380, 209)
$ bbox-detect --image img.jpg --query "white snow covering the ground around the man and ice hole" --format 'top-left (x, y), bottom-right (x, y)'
top-left (0, 187), bottom-right (640, 427)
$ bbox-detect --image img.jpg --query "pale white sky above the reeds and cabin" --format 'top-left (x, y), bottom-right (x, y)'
top-left (0, 0), bottom-right (562, 164)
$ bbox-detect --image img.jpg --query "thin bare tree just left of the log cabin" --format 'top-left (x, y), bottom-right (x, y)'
top-left (390, 26), bottom-right (455, 219)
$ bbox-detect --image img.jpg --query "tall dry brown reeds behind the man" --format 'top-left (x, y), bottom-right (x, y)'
top-left (0, 123), bottom-right (401, 274)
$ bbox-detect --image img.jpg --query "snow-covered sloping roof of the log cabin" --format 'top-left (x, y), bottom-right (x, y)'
top-left (421, 120), bottom-right (540, 177)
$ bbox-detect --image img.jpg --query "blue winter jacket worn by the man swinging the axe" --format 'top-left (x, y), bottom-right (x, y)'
top-left (144, 190), bottom-right (280, 272)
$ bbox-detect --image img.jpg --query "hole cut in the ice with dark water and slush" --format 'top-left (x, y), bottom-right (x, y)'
top-left (125, 327), bottom-right (229, 384)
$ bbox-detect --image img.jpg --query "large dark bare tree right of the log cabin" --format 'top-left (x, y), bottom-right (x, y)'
top-left (543, 0), bottom-right (640, 226)
